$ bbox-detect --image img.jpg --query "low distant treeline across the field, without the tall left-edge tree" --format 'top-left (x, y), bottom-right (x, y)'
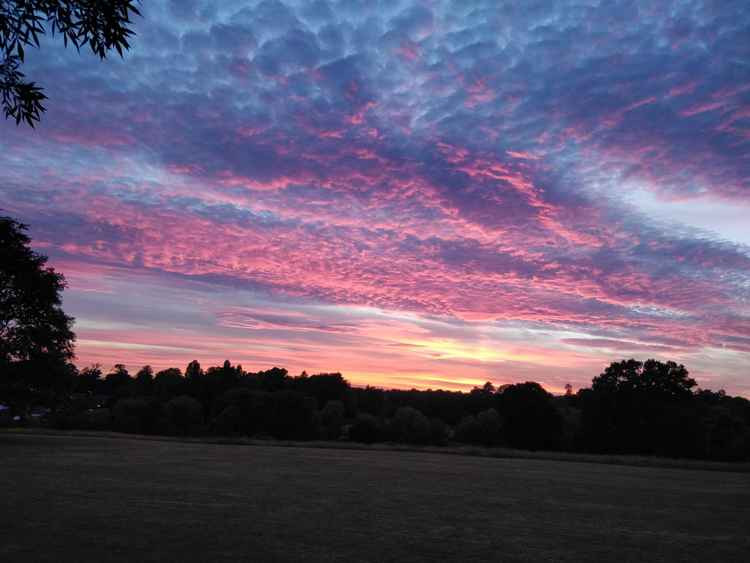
top-left (1, 360), bottom-right (750, 460)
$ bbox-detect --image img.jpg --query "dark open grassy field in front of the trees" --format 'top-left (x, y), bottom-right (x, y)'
top-left (0, 433), bottom-right (750, 562)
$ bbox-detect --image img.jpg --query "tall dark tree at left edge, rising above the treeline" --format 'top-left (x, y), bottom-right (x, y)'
top-left (0, 217), bottom-right (75, 410)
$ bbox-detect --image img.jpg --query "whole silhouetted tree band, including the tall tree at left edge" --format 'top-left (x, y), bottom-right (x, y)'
top-left (0, 217), bottom-right (750, 460)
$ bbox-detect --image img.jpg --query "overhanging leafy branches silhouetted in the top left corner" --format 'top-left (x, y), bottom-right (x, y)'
top-left (0, 0), bottom-right (140, 127)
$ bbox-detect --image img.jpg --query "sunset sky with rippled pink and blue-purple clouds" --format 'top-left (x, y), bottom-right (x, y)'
top-left (0, 0), bottom-right (750, 397)
